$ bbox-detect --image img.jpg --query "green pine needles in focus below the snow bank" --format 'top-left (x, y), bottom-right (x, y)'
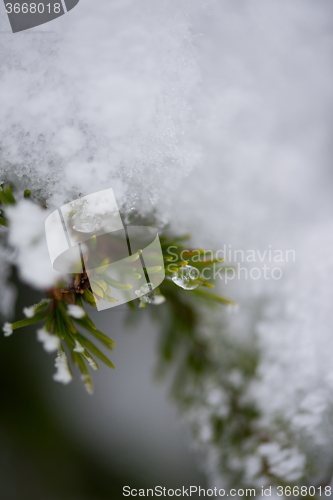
top-left (0, 184), bottom-right (234, 393)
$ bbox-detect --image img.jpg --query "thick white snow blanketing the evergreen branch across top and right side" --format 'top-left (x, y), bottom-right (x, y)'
top-left (0, 0), bottom-right (333, 484)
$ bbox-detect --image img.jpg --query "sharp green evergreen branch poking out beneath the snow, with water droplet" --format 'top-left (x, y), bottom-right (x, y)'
top-left (0, 191), bottom-right (234, 392)
